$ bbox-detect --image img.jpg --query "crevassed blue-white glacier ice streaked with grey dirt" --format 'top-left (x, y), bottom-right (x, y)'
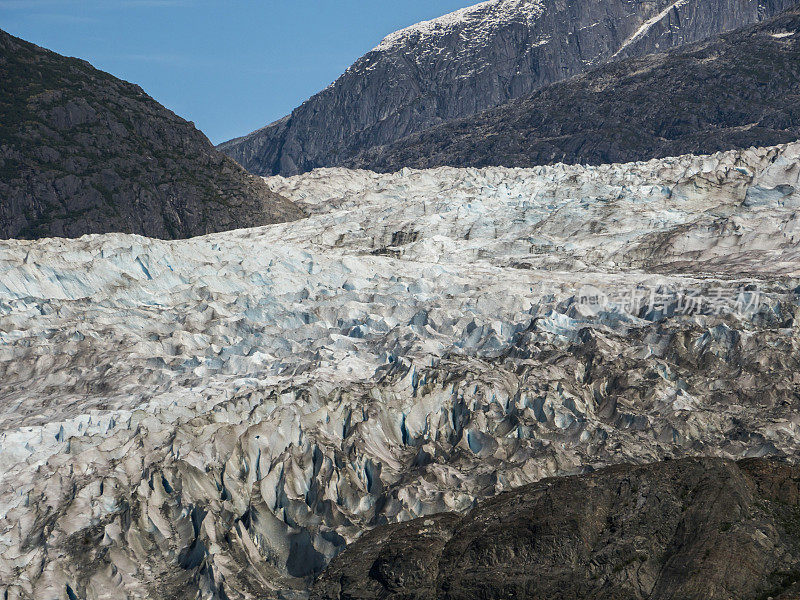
top-left (0, 144), bottom-right (800, 600)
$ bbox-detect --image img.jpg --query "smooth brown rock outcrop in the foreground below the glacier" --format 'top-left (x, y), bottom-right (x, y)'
top-left (312, 458), bottom-right (800, 600)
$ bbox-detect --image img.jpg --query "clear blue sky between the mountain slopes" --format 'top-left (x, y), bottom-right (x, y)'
top-left (0, 0), bottom-right (478, 143)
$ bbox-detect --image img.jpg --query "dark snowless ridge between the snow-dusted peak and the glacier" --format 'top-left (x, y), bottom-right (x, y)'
top-left (346, 8), bottom-right (800, 171)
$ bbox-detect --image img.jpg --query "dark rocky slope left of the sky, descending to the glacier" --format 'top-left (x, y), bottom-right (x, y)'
top-left (0, 31), bottom-right (302, 238)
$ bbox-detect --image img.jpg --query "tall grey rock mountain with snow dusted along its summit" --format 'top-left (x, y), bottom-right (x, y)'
top-left (219, 0), bottom-right (794, 175)
